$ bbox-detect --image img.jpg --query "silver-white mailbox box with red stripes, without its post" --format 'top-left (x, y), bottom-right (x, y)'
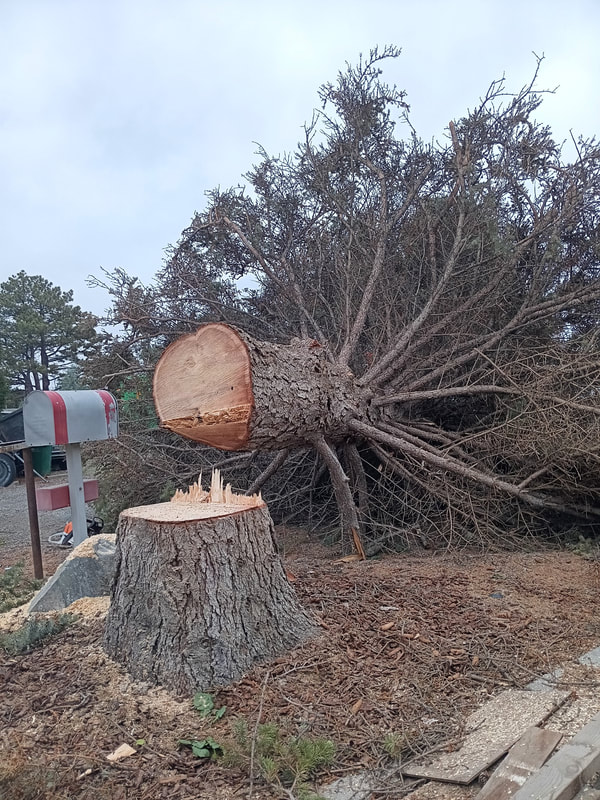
top-left (23, 389), bottom-right (119, 447)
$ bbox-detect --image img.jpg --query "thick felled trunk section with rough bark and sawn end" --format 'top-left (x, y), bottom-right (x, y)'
top-left (154, 323), bottom-right (364, 450)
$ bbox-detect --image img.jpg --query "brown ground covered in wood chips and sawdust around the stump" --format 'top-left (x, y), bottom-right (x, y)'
top-left (0, 529), bottom-right (600, 800)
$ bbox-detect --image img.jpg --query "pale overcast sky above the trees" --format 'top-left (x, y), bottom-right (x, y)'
top-left (0, 0), bottom-right (600, 314)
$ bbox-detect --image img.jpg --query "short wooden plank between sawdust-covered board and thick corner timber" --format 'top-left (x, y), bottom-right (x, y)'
top-left (476, 728), bottom-right (562, 800)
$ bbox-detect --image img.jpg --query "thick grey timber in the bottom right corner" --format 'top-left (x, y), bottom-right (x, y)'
top-left (513, 714), bottom-right (600, 800)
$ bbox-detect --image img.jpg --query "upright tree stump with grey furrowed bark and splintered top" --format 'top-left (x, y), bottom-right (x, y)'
top-left (104, 480), bottom-right (316, 695)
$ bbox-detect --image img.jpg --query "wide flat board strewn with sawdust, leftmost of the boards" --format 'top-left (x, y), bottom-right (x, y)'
top-left (402, 689), bottom-right (568, 784)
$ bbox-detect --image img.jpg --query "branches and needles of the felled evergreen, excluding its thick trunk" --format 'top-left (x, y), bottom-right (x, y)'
top-left (86, 47), bottom-right (600, 546)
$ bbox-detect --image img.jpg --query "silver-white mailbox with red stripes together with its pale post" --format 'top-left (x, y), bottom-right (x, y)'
top-left (23, 389), bottom-right (119, 545)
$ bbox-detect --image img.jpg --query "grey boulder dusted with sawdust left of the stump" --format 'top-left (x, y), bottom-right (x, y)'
top-left (28, 533), bottom-right (116, 614)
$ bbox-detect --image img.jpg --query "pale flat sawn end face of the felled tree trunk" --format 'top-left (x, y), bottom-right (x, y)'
top-left (154, 324), bottom-right (253, 450)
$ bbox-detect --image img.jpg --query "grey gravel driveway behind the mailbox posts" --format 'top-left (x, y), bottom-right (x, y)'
top-left (0, 472), bottom-right (101, 568)
